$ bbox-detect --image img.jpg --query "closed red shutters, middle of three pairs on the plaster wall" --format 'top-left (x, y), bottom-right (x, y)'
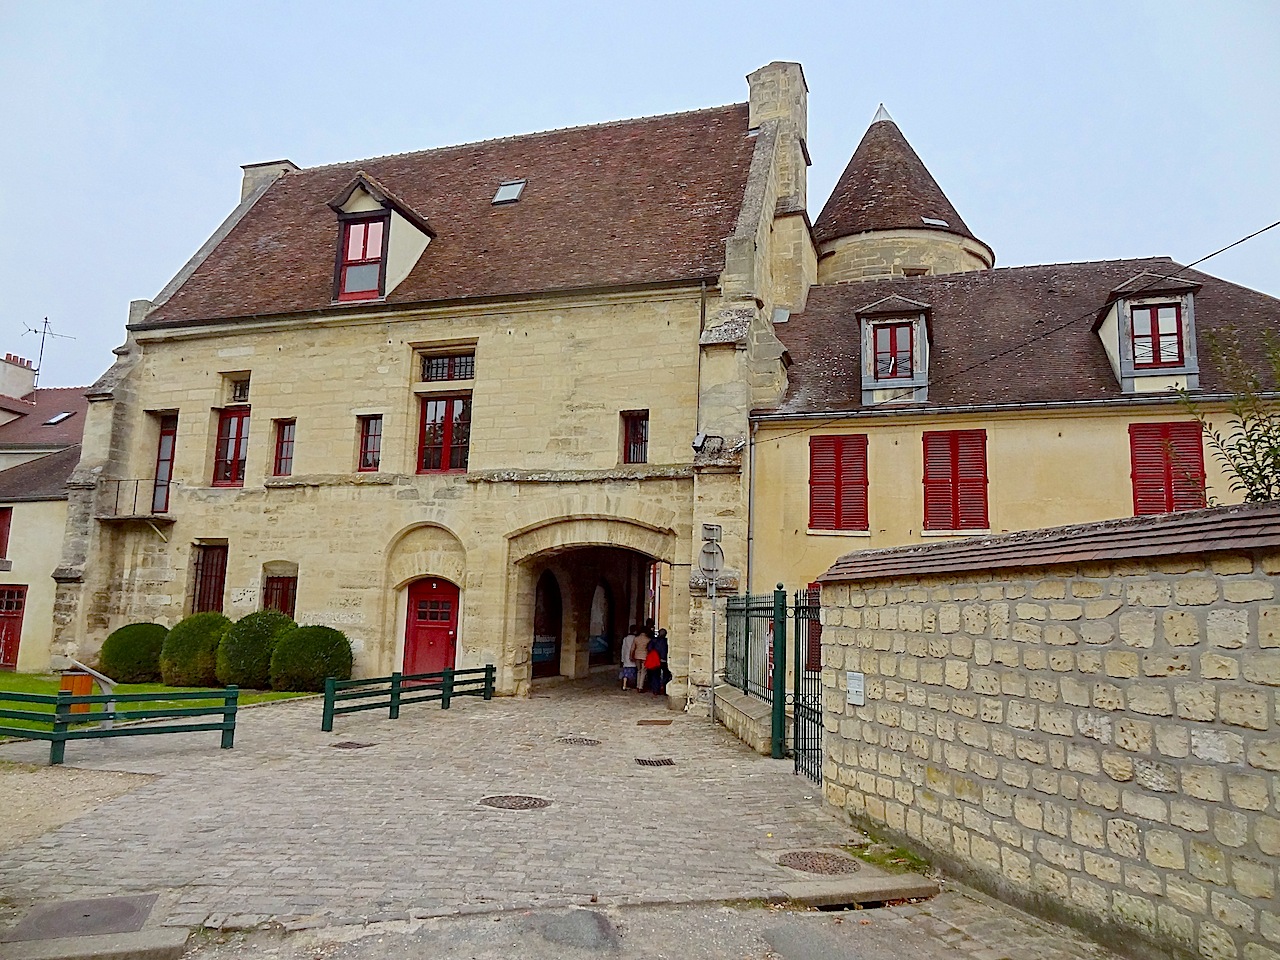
top-left (924, 430), bottom-right (988, 530)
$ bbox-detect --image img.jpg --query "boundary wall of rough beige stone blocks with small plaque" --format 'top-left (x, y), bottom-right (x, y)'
top-left (822, 548), bottom-right (1280, 960)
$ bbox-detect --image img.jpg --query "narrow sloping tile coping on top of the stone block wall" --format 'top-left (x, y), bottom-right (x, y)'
top-left (818, 503), bottom-right (1280, 584)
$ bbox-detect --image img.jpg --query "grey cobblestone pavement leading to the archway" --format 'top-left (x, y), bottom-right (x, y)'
top-left (0, 684), bottom-right (855, 928)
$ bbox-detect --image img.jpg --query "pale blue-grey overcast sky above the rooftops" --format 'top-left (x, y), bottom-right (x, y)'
top-left (0, 0), bottom-right (1280, 387)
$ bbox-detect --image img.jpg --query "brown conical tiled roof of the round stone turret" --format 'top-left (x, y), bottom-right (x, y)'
top-left (813, 104), bottom-right (986, 246)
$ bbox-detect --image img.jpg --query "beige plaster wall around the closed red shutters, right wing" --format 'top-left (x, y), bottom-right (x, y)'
top-left (751, 404), bottom-right (1240, 593)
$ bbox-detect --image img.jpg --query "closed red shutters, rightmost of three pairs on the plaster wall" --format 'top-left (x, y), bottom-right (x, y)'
top-left (1129, 420), bottom-right (1206, 516)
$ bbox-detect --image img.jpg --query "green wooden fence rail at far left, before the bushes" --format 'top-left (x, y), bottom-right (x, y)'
top-left (0, 686), bottom-right (239, 767)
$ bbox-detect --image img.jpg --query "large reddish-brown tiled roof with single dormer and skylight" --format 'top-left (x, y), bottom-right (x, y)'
top-left (146, 104), bottom-right (755, 324)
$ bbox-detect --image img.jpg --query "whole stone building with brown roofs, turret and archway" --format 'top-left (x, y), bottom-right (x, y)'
top-left (55, 63), bottom-right (1280, 705)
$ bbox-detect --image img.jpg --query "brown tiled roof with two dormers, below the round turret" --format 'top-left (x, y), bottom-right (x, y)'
top-left (777, 257), bottom-right (1280, 413)
